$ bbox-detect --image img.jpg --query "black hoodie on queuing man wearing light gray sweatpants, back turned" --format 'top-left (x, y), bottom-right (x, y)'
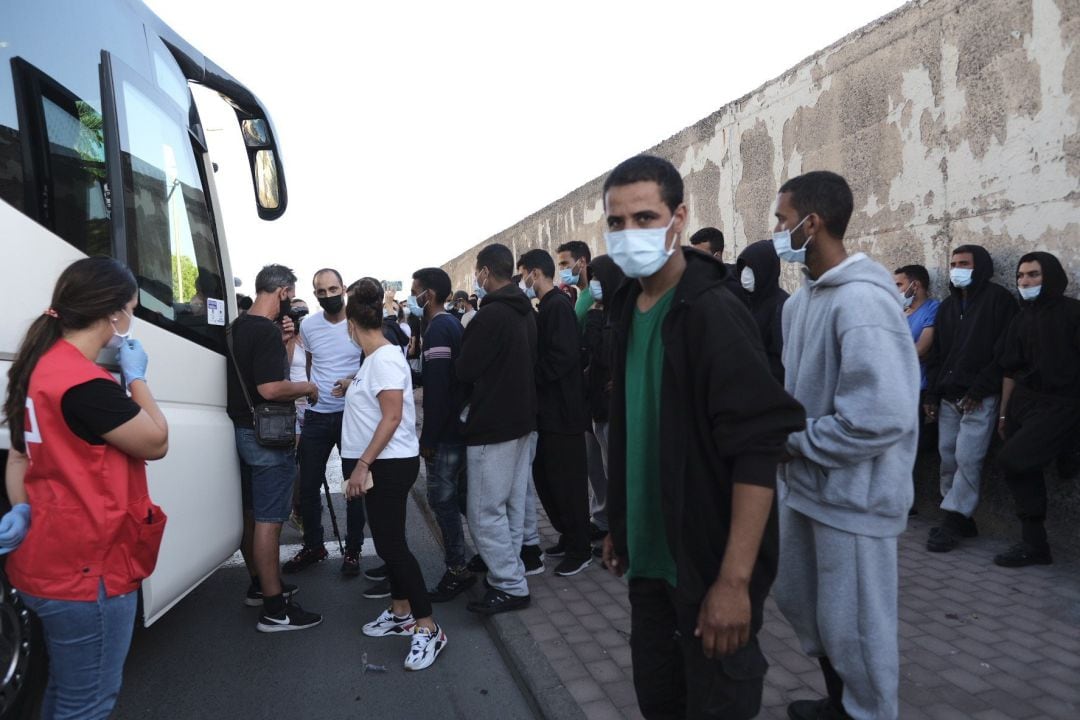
top-left (454, 283), bottom-right (537, 445)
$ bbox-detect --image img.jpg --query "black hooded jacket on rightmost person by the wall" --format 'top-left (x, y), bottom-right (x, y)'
top-left (998, 253), bottom-right (1080, 399)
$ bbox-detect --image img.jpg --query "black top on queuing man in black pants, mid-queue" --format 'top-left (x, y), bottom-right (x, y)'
top-left (536, 287), bottom-right (589, 435)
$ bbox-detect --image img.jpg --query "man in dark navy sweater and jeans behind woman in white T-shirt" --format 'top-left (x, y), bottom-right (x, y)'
top-left (408, 268), bottom-right (476, 602)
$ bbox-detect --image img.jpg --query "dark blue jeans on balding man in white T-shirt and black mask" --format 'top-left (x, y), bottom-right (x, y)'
top-left (299, 408), bottom-right (367, 552)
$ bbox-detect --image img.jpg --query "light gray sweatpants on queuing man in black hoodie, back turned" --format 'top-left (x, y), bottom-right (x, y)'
top-left (467, 435), bottom-right (534, 597)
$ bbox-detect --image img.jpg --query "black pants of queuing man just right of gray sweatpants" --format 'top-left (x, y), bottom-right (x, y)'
top-left (532, 431), bottom-right (591, 555)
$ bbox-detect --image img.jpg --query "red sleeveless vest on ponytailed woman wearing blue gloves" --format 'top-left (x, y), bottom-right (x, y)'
top-left (4, 340), bottom-right (165, 600)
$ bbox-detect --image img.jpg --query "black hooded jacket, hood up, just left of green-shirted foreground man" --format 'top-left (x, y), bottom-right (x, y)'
top-left (582, 255), bottom-right (626, 422)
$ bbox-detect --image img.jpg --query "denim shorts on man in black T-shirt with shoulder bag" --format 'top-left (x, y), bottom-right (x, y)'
top-left (237, 427), bottom-right (296, 522)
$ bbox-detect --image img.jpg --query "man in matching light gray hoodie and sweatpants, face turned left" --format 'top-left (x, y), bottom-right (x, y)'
top-left (773, 172), bottom-right (919, 720)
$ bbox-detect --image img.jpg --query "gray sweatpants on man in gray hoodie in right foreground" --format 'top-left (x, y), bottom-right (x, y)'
top-left (772, 502), bottom-right (900, 720)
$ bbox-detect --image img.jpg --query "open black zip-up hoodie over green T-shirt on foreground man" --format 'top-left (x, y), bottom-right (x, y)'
top-left (608, 248), bottom-right (806, 633)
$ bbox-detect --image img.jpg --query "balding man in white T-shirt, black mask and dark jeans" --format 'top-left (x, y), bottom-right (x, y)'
top-left (283, 268), bottom-right (365, 576)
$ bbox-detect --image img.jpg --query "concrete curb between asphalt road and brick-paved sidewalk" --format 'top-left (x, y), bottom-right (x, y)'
top-left (413, 477), bottom-right (585, 720)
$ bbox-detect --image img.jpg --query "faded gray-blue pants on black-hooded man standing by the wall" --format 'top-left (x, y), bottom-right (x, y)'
top-left (937, 395), bottom-right (998, 517)
